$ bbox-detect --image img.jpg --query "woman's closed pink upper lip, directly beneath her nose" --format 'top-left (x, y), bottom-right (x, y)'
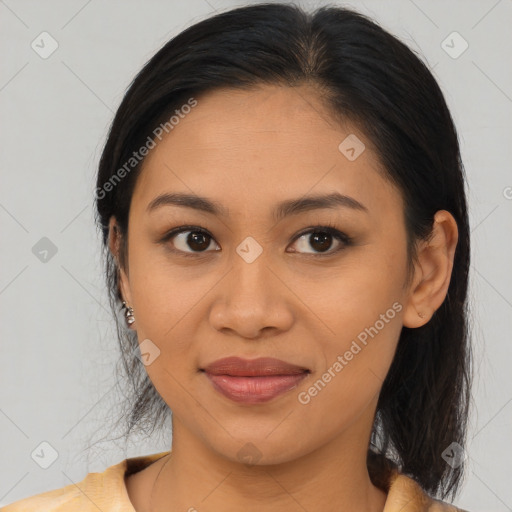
top-left (203, 357), bottom-right (309, 377)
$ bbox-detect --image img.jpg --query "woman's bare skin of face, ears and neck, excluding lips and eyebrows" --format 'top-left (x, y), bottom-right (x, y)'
top-left (110, 85), bottom-right (457, 512)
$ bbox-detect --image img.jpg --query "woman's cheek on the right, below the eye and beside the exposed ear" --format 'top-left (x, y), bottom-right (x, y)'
top-left (296, 244), bottom-right (406, 396)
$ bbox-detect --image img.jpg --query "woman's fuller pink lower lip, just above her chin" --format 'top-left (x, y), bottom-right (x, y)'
top-left (206, 372), bottom-right (307, 404)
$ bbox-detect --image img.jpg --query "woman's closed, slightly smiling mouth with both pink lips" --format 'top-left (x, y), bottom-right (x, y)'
top-left (201, 357), bottom-right (310, 404)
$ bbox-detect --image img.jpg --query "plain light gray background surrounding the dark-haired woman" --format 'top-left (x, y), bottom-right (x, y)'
top-left (0, 0), bottom-right (512, 511)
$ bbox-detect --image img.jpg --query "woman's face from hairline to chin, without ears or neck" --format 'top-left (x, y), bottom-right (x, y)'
top-left (116, 86), bottom-right (420, 463)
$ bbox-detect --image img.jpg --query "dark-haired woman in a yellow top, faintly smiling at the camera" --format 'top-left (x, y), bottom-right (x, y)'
top-left (5, 4), bottom-right (471, 512)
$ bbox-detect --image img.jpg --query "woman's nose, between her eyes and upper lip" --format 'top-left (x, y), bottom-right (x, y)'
top-left (210, 248), bottom-right (294, 339)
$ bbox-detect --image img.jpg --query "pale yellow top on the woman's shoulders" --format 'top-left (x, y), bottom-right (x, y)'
top-left (2, 452), bottom-right (467, 512)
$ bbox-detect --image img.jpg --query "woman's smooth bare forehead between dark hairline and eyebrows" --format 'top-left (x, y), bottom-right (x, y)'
top-left (130, 86), bottom-right (397, 218)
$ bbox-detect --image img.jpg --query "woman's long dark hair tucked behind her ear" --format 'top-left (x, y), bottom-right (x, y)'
top-left (96, 3), bottom-right (471, 498)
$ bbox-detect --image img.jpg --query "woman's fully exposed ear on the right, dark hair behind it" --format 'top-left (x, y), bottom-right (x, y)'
top-left (403, 210), bottom-right (458, 328)
